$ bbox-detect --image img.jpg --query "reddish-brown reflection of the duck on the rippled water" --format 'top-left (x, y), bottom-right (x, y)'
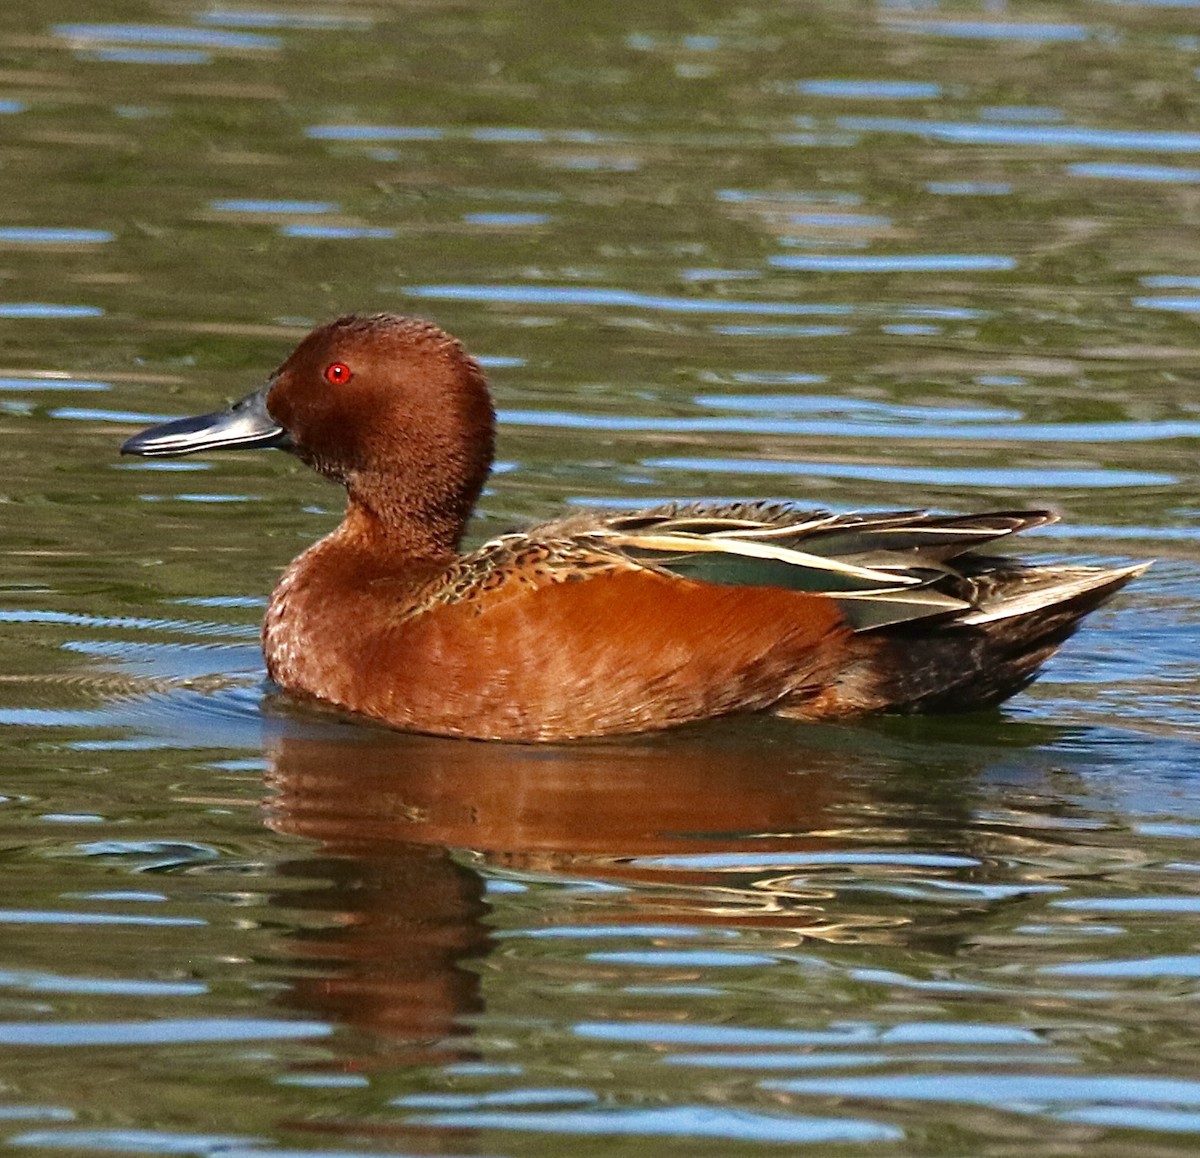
top-left (266, 719), bottom-right (1032, 1062)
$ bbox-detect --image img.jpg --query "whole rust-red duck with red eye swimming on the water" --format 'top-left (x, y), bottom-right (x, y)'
top-left (121, 313), bottom-right (1148, 743)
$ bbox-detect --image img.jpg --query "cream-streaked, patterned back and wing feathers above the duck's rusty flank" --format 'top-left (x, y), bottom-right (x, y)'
top-left (463, 502), bottom-right (1132, 631)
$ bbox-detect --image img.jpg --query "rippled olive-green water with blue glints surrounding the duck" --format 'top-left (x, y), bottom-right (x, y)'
top-left (0, 0), bottom-right (1200, 1158)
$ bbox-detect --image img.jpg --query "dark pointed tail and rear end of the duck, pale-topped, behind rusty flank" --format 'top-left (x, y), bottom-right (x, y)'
top-left (845, 564), bottom-right (1148, 713)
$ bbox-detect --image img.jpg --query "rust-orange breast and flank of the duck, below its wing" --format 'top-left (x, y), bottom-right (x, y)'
top-left (263, 525), bottom-right (850, 739)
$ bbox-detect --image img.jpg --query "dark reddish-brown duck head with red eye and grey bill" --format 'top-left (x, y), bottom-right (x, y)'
top-left (121, 314), bottom-right (494, 553)
